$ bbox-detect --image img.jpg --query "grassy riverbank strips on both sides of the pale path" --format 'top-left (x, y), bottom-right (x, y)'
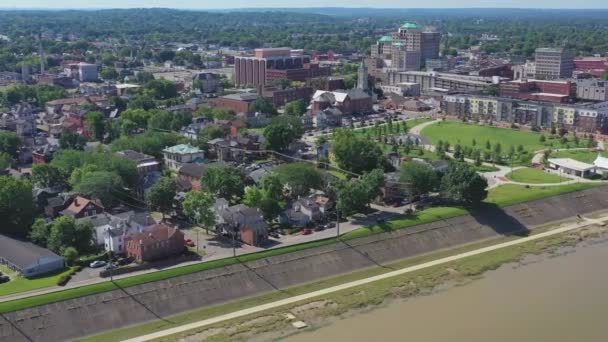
top-left (77, 216), bottom-right (600, 342)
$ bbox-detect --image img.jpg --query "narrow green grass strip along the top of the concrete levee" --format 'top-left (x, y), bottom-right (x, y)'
top-left (0, 183), bottom-right (598, 313)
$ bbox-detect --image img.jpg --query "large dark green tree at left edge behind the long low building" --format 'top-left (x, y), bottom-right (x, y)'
top-left (0, 176), bottom-right (36, 237)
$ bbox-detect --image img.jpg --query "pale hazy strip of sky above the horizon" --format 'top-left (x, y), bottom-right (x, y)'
top-left (0, 0), bottom-right (608, 9)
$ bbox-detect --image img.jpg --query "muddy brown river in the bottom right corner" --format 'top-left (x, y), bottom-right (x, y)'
top-left (285, 241), bottom-right (608, 342)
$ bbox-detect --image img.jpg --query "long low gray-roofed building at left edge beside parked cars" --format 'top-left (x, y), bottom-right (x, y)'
top-left (0, 234), bottom-right (65, 278)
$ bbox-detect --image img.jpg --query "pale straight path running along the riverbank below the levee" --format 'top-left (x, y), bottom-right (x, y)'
top-left (126, 212), bottom-right (608, 342)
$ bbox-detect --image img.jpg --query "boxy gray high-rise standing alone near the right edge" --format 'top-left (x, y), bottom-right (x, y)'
top-left (535, 48), bottom-right (574, 80)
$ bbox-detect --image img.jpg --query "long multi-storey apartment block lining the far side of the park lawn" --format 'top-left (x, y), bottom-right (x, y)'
top-left (441, 94), bottom-right (608, 134)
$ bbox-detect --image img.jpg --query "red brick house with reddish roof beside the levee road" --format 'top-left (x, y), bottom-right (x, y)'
top-left (124, 224), bottom-right (184, 263)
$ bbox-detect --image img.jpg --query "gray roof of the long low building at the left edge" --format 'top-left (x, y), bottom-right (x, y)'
top-left (0, 234), bottom-right (61, 269)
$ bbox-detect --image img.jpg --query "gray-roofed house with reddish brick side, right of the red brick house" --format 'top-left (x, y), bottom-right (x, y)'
top-left (221, 204), bottom-right (268, 246)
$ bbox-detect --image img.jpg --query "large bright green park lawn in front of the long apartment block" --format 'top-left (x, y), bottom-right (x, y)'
top-left (422, 121), bottom-right (545, 152)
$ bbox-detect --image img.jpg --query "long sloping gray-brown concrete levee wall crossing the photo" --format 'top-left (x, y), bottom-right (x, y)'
top-left (0, 187), bottom-right (608, 342)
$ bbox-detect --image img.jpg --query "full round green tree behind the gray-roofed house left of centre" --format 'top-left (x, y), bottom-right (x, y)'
top-left (201, 166), bottom-right (245, 203)
